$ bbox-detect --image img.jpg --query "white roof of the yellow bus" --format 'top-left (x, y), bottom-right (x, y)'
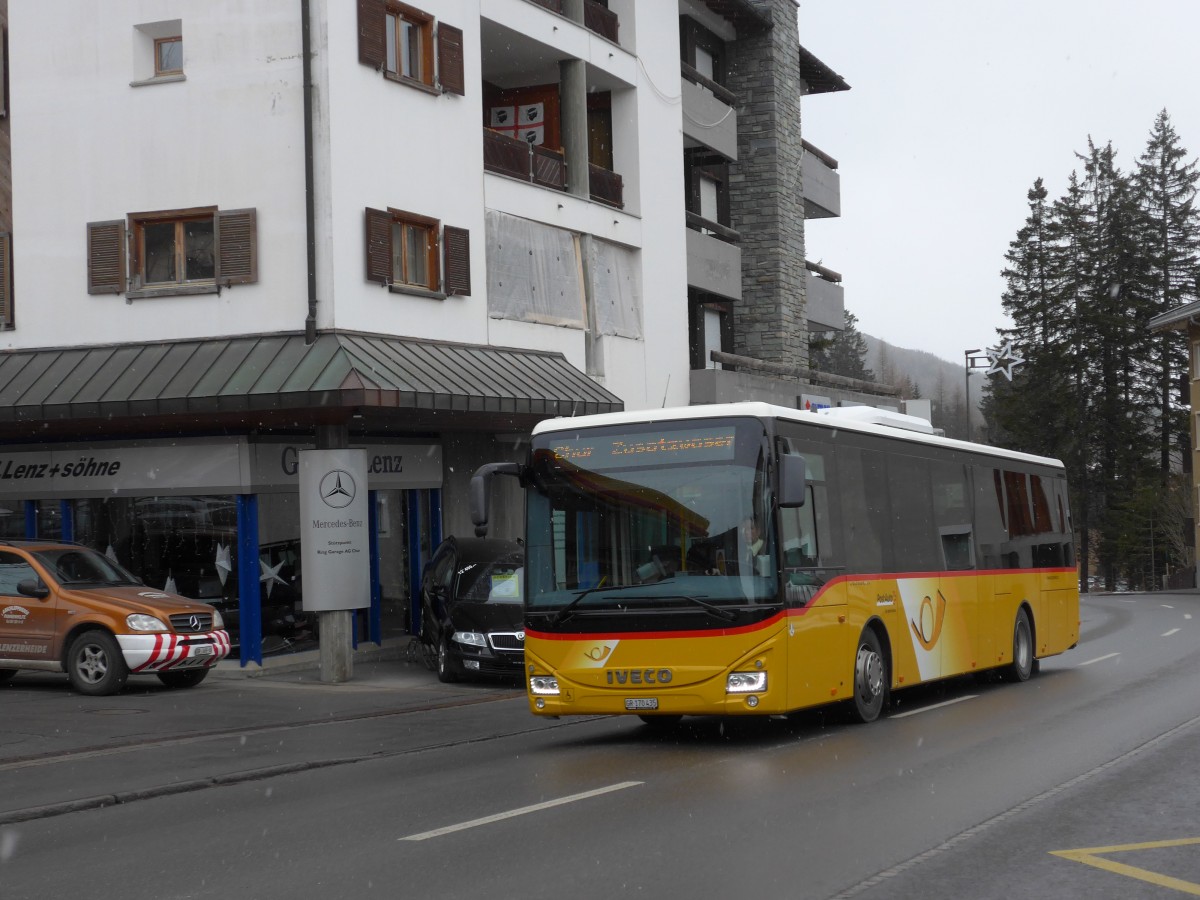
top-left (533, 401), bottom-right (1063, 469)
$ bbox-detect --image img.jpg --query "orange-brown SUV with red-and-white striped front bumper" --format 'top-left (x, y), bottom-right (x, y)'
top-left (0, 540), bottom-right (229, 696)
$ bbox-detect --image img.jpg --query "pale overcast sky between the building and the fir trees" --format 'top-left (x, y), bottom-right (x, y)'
top-left (799, 0), bottom-right (1200, 362)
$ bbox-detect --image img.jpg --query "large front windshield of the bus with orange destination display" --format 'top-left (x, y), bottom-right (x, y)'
top-left (526, 419), bottom-right (779, 624)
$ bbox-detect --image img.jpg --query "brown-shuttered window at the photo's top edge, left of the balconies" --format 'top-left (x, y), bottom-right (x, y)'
top-left (359, 0), bottom-right (466, 95)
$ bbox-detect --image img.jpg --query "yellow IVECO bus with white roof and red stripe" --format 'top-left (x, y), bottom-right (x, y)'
top-left (470, 403), bottom-right (1079, 725)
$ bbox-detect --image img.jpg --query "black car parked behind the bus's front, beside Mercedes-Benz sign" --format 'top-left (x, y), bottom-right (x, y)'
top-left (421, 538), bottom-right (524, 682)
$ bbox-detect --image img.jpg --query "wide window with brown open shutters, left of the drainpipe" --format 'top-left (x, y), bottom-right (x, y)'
top-left (88, 206), bottom-right (258, 299)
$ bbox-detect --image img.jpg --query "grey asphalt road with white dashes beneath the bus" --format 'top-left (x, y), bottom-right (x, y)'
top-left (0, 593), bottom-right (1200, 900)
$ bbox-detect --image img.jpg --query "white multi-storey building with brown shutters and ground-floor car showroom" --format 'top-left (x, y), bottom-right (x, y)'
top-left (0, 0), bottom-right (864, 665)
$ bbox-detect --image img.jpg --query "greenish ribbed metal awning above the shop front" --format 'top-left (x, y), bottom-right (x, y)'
top-left (0, 331), bottom-right (624, 437)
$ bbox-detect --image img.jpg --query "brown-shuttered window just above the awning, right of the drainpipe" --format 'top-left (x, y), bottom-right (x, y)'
top-left (366, 208), bottom-right (470, 296)
